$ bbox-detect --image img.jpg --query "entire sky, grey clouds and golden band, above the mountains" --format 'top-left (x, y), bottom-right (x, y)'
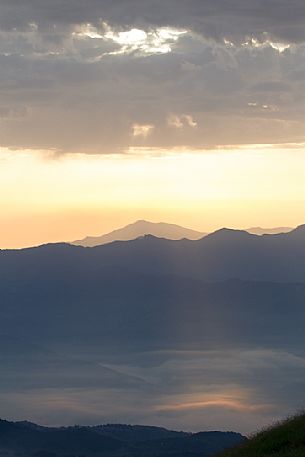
top-left (0, 0), bottom-right (305, 248)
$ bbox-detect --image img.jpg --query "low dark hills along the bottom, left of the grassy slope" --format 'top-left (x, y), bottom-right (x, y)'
top-left (0, 421), bottom-right (244, 457)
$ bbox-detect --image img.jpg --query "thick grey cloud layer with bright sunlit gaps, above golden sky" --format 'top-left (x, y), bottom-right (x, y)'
top-left (0, 0), bottom-right (305, 154)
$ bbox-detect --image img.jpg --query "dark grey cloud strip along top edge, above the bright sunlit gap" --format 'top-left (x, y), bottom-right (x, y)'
top-left (0, 0), bottom-right (305, 42)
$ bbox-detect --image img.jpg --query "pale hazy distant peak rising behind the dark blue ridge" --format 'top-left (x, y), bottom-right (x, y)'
top-left (71, 221), bottom-right (206, 247)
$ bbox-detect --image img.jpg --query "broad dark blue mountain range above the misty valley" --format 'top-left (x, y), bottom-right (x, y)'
top-left (0, 226), bottom-right (305, 350)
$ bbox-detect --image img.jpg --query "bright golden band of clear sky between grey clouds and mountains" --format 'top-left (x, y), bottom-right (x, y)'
top-left (0, 145), bottom-right (305, 248)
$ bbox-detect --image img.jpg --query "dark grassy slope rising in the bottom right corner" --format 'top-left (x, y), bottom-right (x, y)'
top-left (218, 415), bottom-right (305, 457)
